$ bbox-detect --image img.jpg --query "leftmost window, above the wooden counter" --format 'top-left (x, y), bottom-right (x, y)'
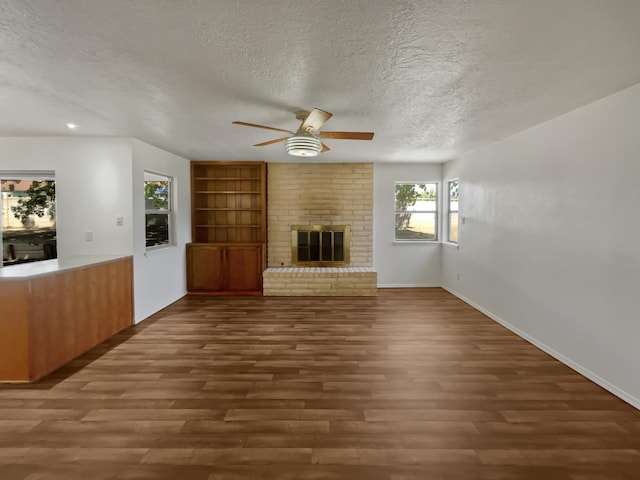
top-left (0, 172), bottom-right (58, 266)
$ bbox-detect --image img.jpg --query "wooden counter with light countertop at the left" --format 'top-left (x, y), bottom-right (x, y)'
top-left (0, 256), bottom-right (133, 382)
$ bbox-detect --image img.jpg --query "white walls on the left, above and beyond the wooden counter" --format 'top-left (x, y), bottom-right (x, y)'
top-left (0, 137), bottom-right (191, 323)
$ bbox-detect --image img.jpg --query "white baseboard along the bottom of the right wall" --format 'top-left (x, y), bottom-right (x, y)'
top-left (440, 285), bottom-right (640, 410)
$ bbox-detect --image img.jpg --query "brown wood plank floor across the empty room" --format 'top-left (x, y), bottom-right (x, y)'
top-left (0, 289), bottom-right (640, 480)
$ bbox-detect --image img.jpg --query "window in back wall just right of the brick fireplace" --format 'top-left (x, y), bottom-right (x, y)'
top-left (395, 183), bottom-right (438, 242)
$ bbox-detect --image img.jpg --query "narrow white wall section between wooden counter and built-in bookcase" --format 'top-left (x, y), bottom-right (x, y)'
top-left (132, 140), bottom-right (191, 323)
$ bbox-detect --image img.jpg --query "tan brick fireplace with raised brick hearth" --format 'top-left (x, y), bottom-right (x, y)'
top-left (263, 163), bottom-right (377, 296)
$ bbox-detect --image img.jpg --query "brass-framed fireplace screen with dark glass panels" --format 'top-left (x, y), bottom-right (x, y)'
top-left (291, 225), bottom-right (351, 267)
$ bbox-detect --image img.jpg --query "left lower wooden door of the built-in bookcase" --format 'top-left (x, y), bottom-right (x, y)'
top-left (187, 244), bottom-right (224, 292)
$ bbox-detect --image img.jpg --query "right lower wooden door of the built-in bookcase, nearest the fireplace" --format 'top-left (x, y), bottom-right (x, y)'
top-left (226, 246), bottom-right (262, 292)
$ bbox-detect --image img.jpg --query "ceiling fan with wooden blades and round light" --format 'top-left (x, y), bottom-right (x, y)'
top-left (231, 108), bottom-right (373, 157)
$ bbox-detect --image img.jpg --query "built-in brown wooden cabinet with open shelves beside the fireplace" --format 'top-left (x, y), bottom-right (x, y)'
top-left (187, 161), bottom-right (267, 294)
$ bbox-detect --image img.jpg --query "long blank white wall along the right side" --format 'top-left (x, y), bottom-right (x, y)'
top-left (443, 84), bottom-right (640, 408)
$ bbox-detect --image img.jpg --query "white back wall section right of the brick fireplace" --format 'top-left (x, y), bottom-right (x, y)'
top-left (373, 163), bottom-right (442, 288)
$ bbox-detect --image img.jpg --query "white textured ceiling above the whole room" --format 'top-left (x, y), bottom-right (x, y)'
top-left (0, 0), bottom-right (640, 162)
